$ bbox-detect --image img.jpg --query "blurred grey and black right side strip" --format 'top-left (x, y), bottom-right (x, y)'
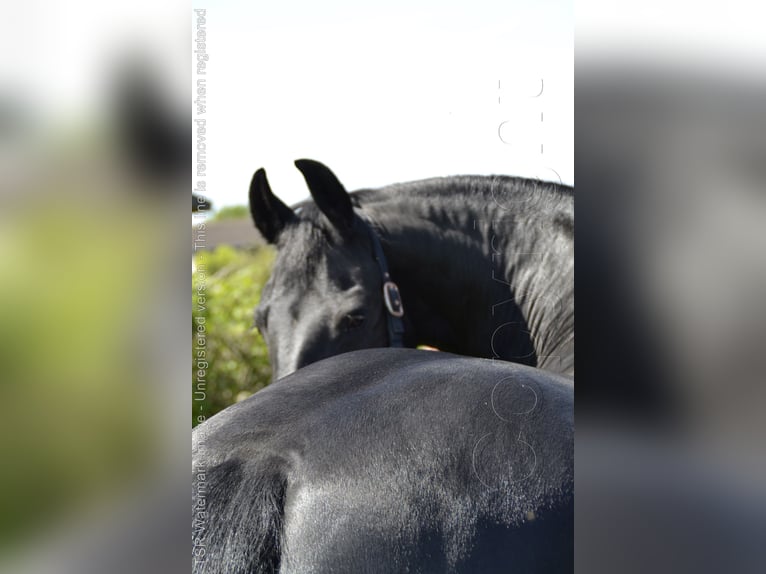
top-left (575, 1), bottom-right (766, 573)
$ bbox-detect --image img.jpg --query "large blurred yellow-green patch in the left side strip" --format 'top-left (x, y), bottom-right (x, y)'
top-left (0, 199), bottom-right (166, 552)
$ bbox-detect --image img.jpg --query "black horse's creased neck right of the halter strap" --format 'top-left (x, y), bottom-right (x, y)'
top-left (367, 182), bottom-right (574, 372)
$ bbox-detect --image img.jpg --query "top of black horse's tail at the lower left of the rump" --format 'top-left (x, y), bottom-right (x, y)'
top-left (192, 457), bottom-right (287, 574)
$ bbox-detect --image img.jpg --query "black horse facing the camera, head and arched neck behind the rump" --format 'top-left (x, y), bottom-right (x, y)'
top-left (250, 160), bottom-right (574, 378)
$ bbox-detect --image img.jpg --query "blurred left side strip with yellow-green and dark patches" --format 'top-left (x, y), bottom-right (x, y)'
top-left (0, 0), bottom-right (191, 573)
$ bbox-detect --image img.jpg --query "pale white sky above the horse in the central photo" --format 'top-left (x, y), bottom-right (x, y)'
top-left (193, 0), bottom-right (574, 207)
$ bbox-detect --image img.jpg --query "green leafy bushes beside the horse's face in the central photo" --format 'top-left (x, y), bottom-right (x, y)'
top-left (192, 245), bottom-right (274, 426)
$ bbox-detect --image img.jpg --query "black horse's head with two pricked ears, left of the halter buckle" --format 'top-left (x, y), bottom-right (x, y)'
top-left (250, 159), bottom-right (388, 380)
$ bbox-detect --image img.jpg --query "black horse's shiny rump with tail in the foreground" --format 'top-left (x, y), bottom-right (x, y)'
top-left (192, 349), bottom-right (573, 574)
